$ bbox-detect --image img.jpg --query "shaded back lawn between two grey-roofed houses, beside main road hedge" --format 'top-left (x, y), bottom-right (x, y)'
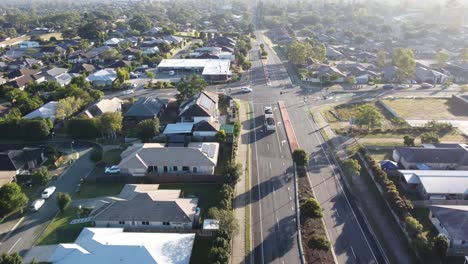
top-left (159, 183), bottom-right (221, 217)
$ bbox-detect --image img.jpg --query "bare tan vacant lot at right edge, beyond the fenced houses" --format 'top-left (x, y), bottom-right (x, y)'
top-left (382, 98), bottom-right (468, 120)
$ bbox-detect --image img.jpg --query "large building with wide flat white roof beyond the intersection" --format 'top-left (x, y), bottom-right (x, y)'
top-left (157, 59), bottom-right (232, 81)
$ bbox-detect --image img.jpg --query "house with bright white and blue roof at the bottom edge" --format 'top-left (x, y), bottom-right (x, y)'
top-left (23, 227), bottom-right (195, 264)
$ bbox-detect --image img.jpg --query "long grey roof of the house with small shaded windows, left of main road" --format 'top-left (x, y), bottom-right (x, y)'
top-left (118, 142), bottom-right (219, 169)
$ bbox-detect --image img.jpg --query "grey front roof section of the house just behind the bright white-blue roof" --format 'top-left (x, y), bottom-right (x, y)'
top-left (94, 193), bottom-right (198, 222)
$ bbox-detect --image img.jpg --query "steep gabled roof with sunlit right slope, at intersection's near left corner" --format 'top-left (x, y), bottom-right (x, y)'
top-left (179, 91), bottom-right (219, 117)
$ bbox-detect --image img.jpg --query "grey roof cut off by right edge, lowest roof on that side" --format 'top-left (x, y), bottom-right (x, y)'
top-left (429, 205), bottom-right (468, 240)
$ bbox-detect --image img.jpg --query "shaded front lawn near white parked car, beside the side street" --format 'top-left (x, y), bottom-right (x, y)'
top-left (73, 182), bottom-right (124, 199)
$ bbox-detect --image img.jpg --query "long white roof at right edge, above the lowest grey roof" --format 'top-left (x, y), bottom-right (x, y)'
top-left (400, 170), bottom-right (468, 194)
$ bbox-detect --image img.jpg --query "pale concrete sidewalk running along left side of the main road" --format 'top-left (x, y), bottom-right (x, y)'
top-left (231, 101), bottom-right (250, 264)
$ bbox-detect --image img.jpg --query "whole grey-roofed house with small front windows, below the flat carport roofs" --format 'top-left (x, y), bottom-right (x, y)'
top-left (118, 142), bottom-right (219, 177)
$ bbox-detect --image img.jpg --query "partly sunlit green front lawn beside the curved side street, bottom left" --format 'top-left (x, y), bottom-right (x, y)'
top-left (36, 207), bottom-right (91, 245)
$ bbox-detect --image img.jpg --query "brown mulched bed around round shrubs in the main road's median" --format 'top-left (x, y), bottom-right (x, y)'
top-left (298, 169), bottom-right (335, 264)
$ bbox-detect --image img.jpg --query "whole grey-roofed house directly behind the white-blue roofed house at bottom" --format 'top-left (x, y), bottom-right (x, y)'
top-left (90, 184), bottom-right (200, 229)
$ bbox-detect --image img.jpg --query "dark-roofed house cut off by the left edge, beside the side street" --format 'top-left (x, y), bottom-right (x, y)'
top-left (0, 148), bottom-right (46, 179)
